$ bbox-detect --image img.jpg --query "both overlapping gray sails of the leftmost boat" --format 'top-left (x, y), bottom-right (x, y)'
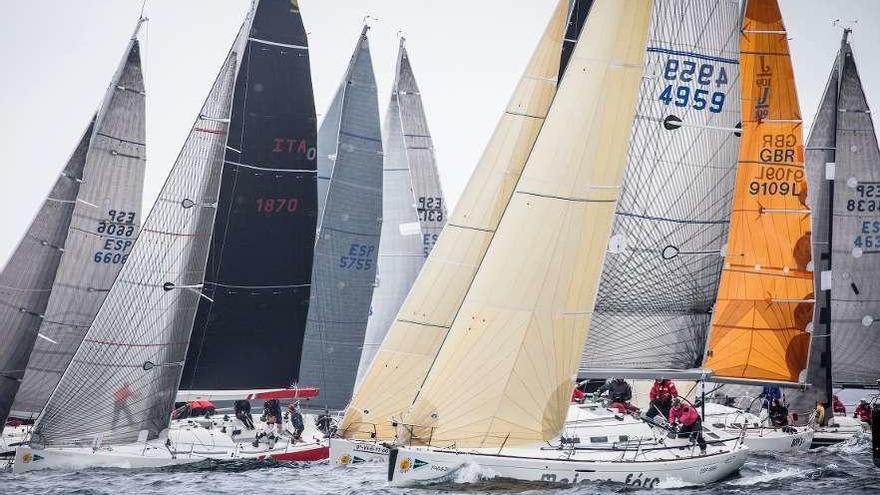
top-left (0, 18), bottom-right (146, 433)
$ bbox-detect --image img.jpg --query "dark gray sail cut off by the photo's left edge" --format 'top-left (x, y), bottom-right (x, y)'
top-left (0, 119), bottom-right (94, 432)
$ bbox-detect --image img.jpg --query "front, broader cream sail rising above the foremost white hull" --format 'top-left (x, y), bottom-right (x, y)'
top-left (399, 0), bottom-right (652, 448)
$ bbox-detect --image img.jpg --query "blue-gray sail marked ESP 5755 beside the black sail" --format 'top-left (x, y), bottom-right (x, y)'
top-left (299, 27), bottom-right (382, 410)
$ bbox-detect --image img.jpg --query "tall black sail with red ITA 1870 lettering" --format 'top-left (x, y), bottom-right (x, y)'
top-left (180, 0), bottom-right (317, 396)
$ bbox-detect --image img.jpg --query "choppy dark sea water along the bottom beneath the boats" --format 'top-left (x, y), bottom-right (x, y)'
top-left (0, 435), bottom-right (880, 495)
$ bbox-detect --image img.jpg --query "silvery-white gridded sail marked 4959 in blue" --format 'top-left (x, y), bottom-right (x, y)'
top-left (581, 0), bottom-right (740, 374)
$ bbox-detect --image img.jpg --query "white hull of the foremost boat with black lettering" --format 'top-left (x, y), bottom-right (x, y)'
top-left (388, 447), bottom-right (748, 488)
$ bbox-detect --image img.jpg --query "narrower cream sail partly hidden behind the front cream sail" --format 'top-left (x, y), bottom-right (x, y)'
top-left (340, 0), bottom-right (569, 440)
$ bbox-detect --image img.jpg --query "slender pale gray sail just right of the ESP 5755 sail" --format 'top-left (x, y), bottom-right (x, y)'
top-left (357, 39), bottom-right (430, 381)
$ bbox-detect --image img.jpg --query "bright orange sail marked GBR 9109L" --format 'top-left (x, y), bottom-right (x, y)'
top-left (705, 0), bottom-right (814, 382)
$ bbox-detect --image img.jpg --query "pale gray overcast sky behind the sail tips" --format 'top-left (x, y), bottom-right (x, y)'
top-left (0, 0), bottom-right (880, 260)
